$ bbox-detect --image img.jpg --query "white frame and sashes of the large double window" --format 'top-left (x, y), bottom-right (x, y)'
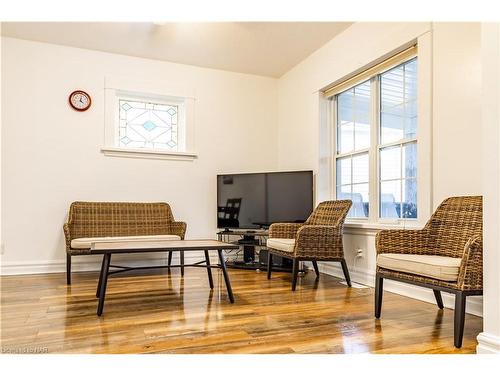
top-left (330, 47), bottom-right (424, 227)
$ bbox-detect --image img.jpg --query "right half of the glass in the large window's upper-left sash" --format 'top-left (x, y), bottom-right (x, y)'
top-left (354, 81), bottom-right (371, 150)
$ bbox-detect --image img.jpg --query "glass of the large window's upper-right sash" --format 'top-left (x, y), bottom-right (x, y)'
top-left (380, 59), bottom-right (417, 144)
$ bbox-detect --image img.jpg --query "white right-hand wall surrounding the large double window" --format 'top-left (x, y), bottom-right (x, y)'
top-left (278, 23), bottom-right (483, 314)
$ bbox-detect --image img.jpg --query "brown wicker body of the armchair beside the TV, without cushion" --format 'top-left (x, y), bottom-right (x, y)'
top-left (269, 200), bottom-right (352, 260)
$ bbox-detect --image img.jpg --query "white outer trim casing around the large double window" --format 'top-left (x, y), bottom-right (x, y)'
top-left (316, 32), bottom-right (433, 229)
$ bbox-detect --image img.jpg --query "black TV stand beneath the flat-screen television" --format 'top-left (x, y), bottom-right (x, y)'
top-left (217, 228), bottom-right (292, 272)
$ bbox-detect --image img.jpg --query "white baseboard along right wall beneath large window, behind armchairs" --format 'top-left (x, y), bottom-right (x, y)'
top-left (318, 262), bottom-right (483, 317)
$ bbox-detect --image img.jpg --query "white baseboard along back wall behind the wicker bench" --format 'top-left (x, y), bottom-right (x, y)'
top-left (0, 253), bottom-right (209, 276)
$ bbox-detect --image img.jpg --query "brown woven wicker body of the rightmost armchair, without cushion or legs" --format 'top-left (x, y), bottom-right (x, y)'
top-left (376, 196), bottom-right (483, 291)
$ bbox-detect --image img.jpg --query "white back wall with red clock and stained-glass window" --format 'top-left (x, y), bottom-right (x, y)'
top-left (2, 38), bottom-right (277, 272)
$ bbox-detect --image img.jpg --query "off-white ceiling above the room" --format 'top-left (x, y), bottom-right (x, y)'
top-left (2, 22), bottom-right (351, 77)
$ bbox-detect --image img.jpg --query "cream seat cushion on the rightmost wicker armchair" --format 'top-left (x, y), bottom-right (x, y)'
top-left (377, 253), bottom-right (462, 281)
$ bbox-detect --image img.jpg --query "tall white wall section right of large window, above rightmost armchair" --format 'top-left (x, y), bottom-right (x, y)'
top-left (432, 23), bottom-right (483, 203)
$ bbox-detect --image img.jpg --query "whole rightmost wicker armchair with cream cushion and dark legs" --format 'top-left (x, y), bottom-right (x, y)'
top-left (375, 196), bottom-right (483, 348)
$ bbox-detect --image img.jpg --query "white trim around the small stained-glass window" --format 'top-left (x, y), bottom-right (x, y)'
top-left (101, 77), bottom-right (198, 161)
